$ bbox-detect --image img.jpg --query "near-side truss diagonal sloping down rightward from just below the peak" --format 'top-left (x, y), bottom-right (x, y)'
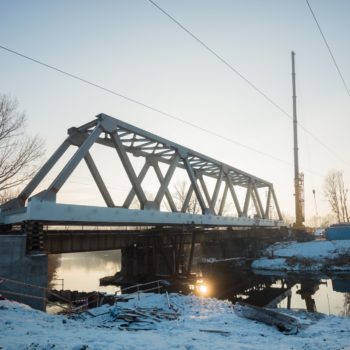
top-left (110, 131), bottom-right (147, 209)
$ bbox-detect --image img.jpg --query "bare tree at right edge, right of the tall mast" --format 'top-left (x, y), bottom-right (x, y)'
top-left (324, 170), bottom-right (349, 222)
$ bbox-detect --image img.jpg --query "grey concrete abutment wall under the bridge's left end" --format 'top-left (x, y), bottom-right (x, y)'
top-left (0, 235), bottom-right (48, 310)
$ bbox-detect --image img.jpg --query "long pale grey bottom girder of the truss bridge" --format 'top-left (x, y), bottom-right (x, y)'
top-left (1, 198), bottom-right (285, 227)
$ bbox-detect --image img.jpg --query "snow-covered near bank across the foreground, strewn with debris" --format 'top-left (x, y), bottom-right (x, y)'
top-left (0, 294), bottom-right (350, 350)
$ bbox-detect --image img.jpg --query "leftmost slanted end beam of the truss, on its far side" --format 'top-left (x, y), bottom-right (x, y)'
top-left (18, 137), bottom-right (71, 205)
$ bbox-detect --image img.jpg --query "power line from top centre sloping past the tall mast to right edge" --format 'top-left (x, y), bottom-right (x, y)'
top-left (147, 0), bottom-right (350, 166)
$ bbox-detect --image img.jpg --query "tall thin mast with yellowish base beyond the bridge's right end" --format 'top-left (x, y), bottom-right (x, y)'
top-left (292, 51), bottom-right (304, 229)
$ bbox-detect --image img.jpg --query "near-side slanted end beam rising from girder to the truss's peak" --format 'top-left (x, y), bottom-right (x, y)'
top-left (43, 125), bottom-right (102, 200)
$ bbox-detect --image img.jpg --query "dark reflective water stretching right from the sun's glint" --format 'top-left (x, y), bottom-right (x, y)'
top-left (201, 270), bottom-right (350, 316)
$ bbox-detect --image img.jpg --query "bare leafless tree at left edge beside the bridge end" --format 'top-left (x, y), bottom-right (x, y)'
top-left (0, 94), bottom-right (45, 202)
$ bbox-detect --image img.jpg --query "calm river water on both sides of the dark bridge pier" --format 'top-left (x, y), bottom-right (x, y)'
top-left (49, 250), bottom-right (350, 316)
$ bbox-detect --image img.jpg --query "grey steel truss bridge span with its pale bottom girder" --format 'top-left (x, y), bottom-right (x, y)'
top-left (0, 114), bottom-right (285, 227)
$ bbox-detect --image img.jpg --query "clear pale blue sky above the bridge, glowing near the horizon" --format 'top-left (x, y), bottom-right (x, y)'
top-left (0, 0), bottom-right (350, 223)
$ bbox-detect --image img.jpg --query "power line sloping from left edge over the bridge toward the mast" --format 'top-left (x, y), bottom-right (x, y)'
top-left (0, 45), bottom-right (291, 165)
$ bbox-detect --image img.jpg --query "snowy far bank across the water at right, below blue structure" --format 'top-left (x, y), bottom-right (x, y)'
top-left (252, 240), bottom-right (350, 272)
